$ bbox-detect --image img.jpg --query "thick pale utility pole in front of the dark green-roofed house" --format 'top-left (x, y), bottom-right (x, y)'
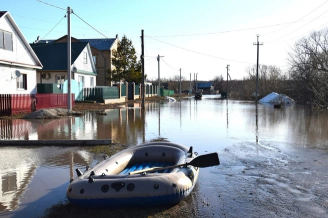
top-left (67, 7), bottom-right (72, 110)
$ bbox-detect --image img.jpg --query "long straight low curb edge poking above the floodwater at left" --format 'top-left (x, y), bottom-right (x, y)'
top-left (0, 139), bottom-right (112, 146)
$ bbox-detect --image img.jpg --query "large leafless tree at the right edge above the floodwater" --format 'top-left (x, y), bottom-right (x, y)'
top-left (289, 29), bottom-right (328, 108)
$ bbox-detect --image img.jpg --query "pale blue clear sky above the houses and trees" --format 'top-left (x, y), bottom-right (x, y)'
top-left (0, 0), bottom-right (328, 81)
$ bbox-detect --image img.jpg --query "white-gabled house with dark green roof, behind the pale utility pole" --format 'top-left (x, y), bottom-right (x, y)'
top-left (30, 42), bottom-right (97, 88)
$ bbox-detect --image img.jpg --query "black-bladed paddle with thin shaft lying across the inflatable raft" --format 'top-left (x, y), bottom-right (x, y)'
top-left (129, 152), bottom-right (220, 175)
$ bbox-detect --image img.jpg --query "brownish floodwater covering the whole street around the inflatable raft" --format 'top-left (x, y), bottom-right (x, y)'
top-left (0, 95), bottom-right (328, 217)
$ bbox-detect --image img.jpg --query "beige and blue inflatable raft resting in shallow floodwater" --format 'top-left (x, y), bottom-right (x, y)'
top-left (66, 142), bottom-right (217, 207)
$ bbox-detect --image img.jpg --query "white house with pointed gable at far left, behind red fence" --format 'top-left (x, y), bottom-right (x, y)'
top-left (0, 11), bottom-right (42, 94)
